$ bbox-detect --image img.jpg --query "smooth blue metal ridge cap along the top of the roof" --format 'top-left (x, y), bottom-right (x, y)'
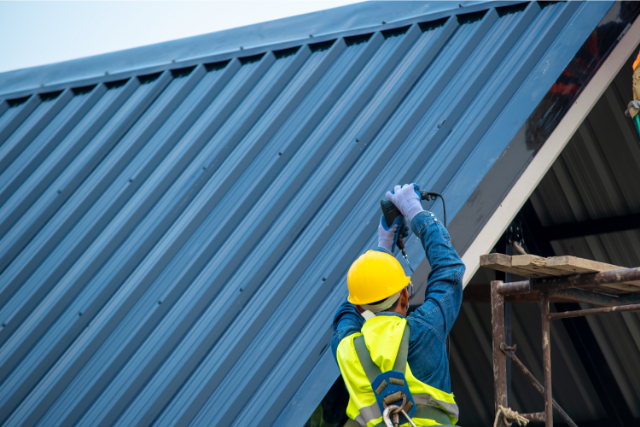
top-left (0, 0), bottom-right (526, 98)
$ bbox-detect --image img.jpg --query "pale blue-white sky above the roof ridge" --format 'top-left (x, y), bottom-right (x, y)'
top-left (0, 0), bottom-right (361, 72)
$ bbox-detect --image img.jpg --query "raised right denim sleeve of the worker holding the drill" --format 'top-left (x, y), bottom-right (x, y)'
top-left (411, 211), bottom-right (465, 342)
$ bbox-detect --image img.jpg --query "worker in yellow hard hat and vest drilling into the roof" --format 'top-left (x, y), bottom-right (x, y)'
top-left (331, 184), bottom-right (465, 427)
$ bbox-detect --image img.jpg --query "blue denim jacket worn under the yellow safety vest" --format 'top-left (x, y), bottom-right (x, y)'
top-left (331, 211), bottom-right (464, 393)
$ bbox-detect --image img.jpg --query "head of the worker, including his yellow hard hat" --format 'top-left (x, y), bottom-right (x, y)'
top-left (347, 251), bottom-right (411, 316)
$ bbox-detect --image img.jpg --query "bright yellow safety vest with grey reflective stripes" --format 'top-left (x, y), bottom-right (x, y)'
top-left (338, 316), bottom-right (458, 427)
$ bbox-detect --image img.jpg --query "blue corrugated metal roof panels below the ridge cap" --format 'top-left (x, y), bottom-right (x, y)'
top-left (0, 2), bottom-right (611, 426)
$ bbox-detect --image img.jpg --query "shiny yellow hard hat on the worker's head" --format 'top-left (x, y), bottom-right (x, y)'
top-left (347, 251), bottom-right (410, 305)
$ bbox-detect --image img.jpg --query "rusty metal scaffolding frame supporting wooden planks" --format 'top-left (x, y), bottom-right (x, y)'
top-left (491, 267), bottom-right (640, 427)
